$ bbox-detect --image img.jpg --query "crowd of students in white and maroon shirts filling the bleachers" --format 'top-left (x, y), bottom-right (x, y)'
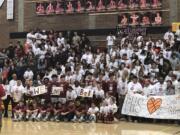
top-left (1, 26), bottom-right (180, 123)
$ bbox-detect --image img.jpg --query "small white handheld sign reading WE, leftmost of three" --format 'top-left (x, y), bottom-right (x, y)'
top-left (32, 85), bottom-right (47, 96)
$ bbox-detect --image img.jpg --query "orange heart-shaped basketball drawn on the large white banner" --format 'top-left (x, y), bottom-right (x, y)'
top-left (147, 98), bottom-right (162, 114)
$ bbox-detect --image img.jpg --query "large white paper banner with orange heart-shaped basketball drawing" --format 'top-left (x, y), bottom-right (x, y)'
top-left (122, 94), bottom-right (180, 119)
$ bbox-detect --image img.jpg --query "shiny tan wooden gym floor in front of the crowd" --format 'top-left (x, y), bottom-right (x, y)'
top-left (0, 119), bottom-right (180, 135)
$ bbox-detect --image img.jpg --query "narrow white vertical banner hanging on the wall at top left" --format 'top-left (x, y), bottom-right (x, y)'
top-left (7, 0), bottom-right (14, 20)
